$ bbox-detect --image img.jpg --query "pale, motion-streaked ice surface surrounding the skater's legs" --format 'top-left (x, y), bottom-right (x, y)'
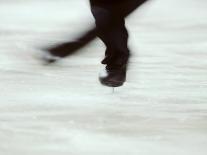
top-left (0, 0), bottom-right (207, 155)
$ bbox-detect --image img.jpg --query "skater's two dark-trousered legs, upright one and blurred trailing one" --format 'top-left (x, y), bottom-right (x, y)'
top-left (47, 0), bottom-right (147, 87)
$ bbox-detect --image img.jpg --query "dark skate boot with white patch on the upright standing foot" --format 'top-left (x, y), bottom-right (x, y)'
top-left (99, 64), bottom-right (127, 87)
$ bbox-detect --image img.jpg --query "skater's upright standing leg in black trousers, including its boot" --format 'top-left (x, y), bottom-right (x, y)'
top-left (91, 0), bottom-right (149, 87)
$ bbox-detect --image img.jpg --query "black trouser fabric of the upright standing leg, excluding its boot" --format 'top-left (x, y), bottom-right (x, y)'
top-left (90, 0), bottom-right (146, 65)
